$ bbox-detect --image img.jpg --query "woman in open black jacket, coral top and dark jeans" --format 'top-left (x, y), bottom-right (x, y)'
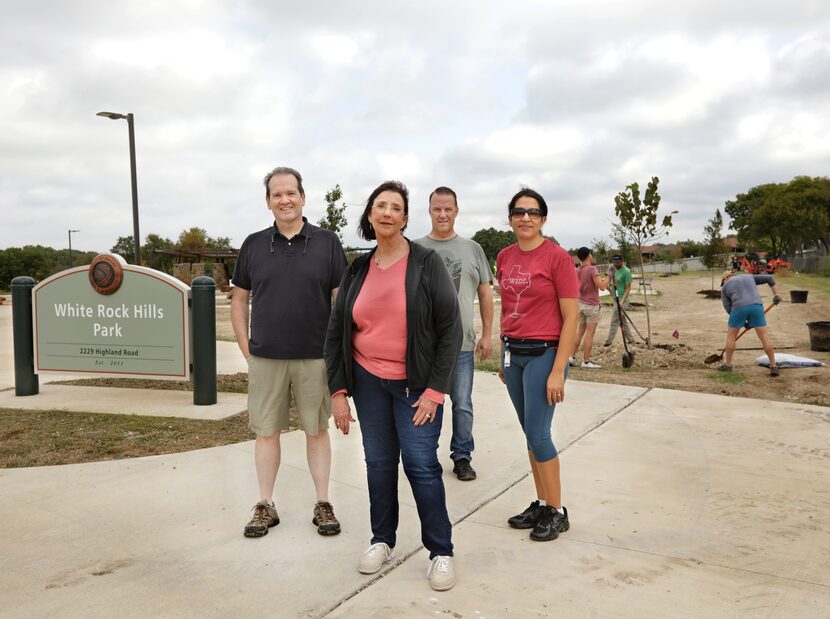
top-left (325, 181), bottom-right (462, 590)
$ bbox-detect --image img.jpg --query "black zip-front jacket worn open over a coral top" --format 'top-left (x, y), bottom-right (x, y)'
top-left (324, 239), bottom-right (462, 394)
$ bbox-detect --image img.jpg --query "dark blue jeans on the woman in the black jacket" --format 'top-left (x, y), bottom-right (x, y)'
top-left (352, 363), bottom-right (453, 559)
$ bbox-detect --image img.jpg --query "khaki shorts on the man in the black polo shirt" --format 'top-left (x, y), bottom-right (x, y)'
top-left (248, 355), bottom-right (331, 436)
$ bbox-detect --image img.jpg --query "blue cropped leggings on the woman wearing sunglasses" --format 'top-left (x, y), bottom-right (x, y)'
top-left (501, 348), bottom-right (568, 462)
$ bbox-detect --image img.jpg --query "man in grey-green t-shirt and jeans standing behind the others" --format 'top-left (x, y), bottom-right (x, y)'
top-left (415, 187), bottom-right (493, 481)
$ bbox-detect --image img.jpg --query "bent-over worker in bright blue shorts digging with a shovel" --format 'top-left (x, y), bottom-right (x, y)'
top-left (718, 271), bottom-right (781, 376)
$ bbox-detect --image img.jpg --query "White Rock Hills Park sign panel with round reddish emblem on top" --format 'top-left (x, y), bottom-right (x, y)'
top-left (32, 254), bottom-right (190, 380)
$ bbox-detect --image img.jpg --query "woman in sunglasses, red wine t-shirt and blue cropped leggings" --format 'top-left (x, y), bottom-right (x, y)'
top-left (496, 189), bottom-right (579, 541)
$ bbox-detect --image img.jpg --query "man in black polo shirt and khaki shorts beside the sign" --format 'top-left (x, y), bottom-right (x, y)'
top-left (231, 168), bottom-right (346, 537)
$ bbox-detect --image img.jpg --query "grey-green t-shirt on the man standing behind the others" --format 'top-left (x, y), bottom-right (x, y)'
top-left (415, 235), bottom-right (493, 352)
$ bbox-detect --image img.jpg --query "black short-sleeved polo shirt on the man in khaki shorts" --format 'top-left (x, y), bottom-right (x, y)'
top-left (233, 217), bottom-right (346, 359)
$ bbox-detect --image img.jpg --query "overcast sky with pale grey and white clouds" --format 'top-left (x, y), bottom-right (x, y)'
top-left (0, 0), bottom-right (830, 251)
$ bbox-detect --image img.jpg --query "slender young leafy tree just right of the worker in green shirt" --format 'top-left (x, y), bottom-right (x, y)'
top-left (614, 176), bottom-right (677, 348)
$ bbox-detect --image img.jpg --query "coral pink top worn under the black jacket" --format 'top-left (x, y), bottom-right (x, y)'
top-left (348, 254), bottom-right (444, 404)
